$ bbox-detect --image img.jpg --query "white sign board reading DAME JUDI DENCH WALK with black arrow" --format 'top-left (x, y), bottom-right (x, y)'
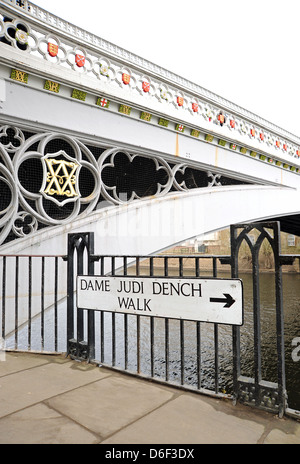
top-left (77, 276), bottom-right (243, 326)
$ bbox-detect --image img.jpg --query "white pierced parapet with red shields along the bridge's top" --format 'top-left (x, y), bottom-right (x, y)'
top-left (0, 0), bottom-right (300, 158)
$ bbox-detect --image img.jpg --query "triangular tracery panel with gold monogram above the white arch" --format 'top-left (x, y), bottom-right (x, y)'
top-left (0, 125), bottom-right (247, 246)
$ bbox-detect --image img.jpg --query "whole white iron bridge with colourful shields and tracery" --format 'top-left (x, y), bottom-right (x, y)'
top-left (0, 0), bottom-right (300, 255)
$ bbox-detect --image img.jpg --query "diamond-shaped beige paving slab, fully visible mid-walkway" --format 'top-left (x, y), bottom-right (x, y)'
top-left (46, 376), bottom-right (173, 438)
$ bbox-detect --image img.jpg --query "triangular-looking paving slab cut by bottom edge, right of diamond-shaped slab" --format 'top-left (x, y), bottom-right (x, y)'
top-left (102, 394), bottom-right (264, 444)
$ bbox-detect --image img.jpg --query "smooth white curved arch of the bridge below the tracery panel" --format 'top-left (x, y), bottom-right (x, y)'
top-left (1, 185), bottom-right (300, 255)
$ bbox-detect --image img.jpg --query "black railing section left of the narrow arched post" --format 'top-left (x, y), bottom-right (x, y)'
top-left (0, 255), bottom-right (67, 353)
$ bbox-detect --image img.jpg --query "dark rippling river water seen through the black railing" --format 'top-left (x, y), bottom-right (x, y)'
top-left (135, 271), bottom-right (300, 410)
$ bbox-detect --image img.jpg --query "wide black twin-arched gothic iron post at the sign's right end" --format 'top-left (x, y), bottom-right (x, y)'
top-left (231, 222), bottom-right (287, 416)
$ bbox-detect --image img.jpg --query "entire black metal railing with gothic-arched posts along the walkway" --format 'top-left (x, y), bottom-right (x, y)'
top-left (0, 223), bottom-right (300, 415)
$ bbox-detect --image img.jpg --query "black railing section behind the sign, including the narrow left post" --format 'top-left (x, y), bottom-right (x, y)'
top-left (68, 233), bottom-right (239, 397)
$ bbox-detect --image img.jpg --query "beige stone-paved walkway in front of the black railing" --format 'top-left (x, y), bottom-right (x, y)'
top-left (0, 353), bottom-right (300, 446)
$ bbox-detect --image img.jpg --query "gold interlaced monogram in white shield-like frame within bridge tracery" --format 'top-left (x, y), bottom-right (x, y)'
top-left (41, 151), bottom-right (81, 206)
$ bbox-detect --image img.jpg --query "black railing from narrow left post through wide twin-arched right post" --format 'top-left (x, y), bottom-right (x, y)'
top-left (68, 227), bottom-right (297, 416)
